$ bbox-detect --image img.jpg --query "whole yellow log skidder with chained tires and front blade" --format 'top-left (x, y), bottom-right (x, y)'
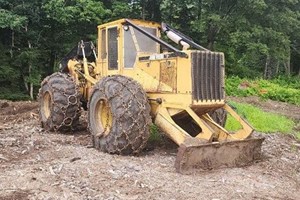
top-left (39, 19), bottom-right (263, 172)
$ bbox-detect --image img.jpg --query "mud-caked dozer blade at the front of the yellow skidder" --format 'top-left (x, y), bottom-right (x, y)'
top-left (175, 137), bottom-right (264, 173)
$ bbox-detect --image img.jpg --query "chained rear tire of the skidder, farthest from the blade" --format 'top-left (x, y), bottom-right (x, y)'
top-left (38, 72), bottom-right (81, 132)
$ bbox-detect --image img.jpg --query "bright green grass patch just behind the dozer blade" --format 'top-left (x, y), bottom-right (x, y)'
top-left (225, 102), bottom-right (300, 134)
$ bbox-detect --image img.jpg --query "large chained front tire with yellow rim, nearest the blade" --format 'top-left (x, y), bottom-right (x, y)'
top-left (88, 75), bottom-right (151, 155)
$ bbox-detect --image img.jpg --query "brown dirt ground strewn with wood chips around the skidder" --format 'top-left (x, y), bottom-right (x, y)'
top-left (0, 98), bottom-right (300, 200)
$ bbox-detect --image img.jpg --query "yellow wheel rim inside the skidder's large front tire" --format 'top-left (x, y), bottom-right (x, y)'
top-left (95, 99), bottom-right (113, 136)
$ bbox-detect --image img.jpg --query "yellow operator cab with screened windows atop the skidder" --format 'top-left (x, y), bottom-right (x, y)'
top-left (98, 19), bottom-right (160, 71)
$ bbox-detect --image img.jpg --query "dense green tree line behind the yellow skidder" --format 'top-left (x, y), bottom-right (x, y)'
top-left (0, 0), bottom-right (300, 98)
